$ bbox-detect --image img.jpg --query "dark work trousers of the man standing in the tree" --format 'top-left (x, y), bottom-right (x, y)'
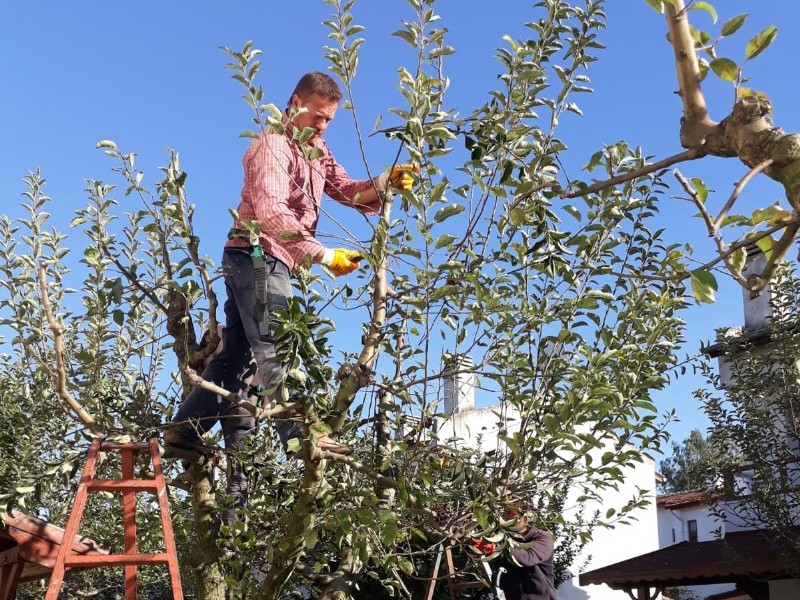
top-left (172, 248), bottom-right (301, 525)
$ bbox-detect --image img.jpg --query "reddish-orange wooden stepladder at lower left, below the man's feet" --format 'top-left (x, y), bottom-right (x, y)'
top-left (45, 438), bottom-right (183, 600)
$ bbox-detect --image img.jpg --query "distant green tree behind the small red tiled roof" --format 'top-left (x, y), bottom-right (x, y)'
top-left (659, 429), bottom-right (714, 494)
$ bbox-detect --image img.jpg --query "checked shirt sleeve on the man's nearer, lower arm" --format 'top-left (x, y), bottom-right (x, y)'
top-left (244, 136), bottom-right (323, 263)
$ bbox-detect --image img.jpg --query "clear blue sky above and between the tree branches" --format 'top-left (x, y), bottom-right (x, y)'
top-left (0, 0), bottom-right (800, 454)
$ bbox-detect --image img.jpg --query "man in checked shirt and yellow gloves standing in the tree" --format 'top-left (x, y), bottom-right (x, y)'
top-left (169, 72), bottom-right (419, 525)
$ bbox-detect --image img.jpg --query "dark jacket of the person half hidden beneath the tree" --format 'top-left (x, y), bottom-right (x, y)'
top-left (490, 528), bottom-right (556, 600)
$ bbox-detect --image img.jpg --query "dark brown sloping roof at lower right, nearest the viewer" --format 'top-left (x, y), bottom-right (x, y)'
top-left (580, 530), bottom-right (786, 589)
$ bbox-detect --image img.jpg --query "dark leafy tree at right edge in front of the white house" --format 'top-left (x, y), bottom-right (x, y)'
top-left (697, 266), bottom-right (800, 573)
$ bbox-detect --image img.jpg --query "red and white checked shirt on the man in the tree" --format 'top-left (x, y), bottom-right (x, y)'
top-left (226, 131), bottom-right (380, 269)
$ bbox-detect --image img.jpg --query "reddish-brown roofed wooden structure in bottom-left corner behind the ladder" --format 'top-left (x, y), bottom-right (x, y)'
top-left (0, 511), bottom-right (110, 600)
